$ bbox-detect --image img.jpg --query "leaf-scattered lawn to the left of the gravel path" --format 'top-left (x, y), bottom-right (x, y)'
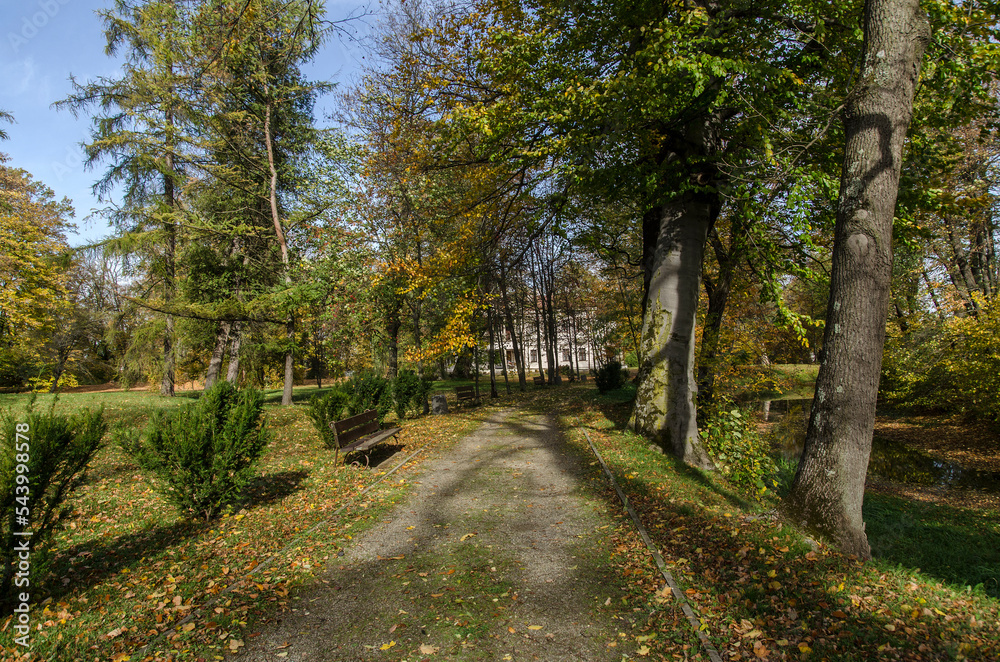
top-left (0, 387), bottom-right (478, 660)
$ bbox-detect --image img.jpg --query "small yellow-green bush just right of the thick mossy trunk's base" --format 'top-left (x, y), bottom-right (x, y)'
top-left (701, 402), bottom-right (777, 498)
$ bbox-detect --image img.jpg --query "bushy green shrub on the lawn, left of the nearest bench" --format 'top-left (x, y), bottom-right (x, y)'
top-left (119, 382), bottom-right (271, 519)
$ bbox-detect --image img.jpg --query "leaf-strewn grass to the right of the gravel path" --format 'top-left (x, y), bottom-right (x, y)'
top-left (540, 386), bottom-right (1000, 662)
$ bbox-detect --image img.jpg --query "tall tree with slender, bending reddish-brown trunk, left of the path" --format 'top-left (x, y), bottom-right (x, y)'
top-left (199, 0), bottom-right (329, 405)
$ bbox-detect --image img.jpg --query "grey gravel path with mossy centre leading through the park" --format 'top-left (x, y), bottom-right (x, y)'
top-left (241, 411), bottom-right (635, 662)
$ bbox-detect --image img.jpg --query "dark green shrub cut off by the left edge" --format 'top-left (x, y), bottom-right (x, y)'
top-left (0, 411), bottom-right (107, 613)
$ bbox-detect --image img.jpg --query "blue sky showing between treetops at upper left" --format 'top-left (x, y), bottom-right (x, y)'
top-left (0, 0), bottom-right (378, 246)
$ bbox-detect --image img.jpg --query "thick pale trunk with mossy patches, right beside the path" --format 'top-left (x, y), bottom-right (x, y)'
top-left (629, 200), bottom-right (718, 469)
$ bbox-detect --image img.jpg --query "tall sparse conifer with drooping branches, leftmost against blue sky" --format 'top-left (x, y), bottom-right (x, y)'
top-left (57, 0), bottom-right (196, 395)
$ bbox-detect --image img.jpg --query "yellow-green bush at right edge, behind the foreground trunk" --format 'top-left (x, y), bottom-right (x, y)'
top-left (880, 305), bottom-right (1000, 426)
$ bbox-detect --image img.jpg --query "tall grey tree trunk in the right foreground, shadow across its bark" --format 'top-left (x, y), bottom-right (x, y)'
top-left (785, 0), bottom-right (930, 558)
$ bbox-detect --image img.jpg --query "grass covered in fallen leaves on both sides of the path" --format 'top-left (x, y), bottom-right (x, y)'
top-left (0, 387), bottom-right (1000, 660)
